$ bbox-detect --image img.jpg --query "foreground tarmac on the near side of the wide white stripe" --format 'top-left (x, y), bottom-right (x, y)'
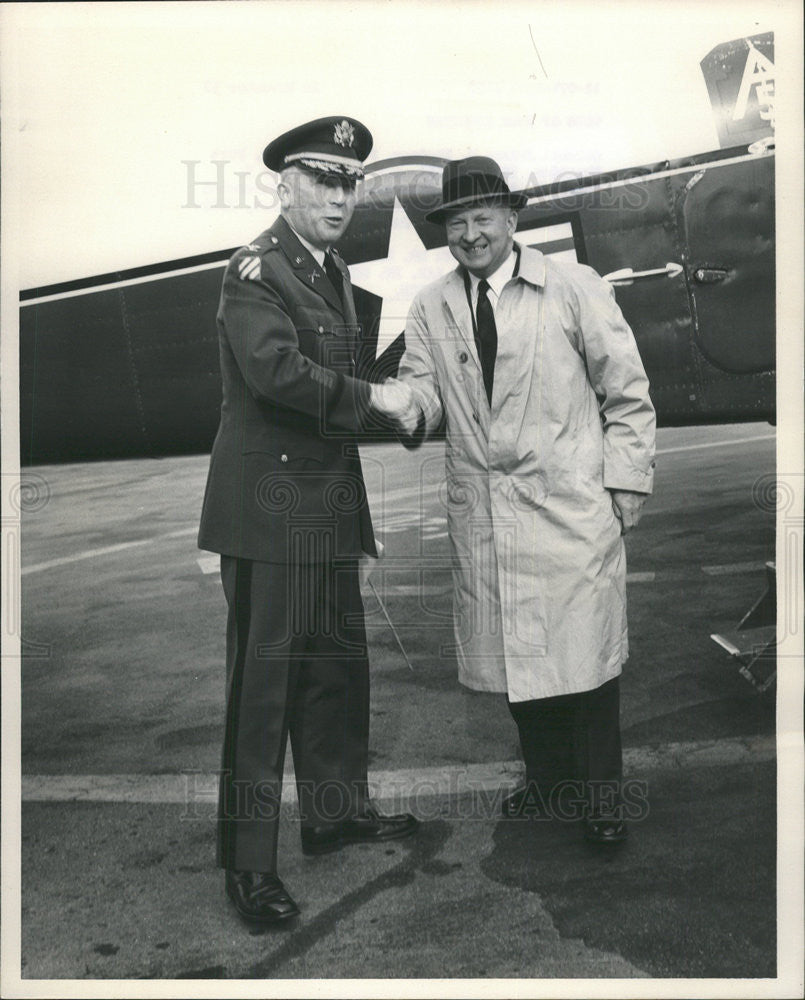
top-left (23, 751), bottom-right (776, 979)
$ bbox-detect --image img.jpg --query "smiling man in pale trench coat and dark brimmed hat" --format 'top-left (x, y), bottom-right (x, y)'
top-left (392, 157), bottom-right (655, 843)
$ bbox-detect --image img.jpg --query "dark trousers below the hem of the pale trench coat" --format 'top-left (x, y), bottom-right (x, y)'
top-left (509, 677), bottom-right (622, 818)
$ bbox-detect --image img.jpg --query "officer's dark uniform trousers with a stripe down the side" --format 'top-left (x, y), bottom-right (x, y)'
top-left (217, 556), bottom-right (369, 872)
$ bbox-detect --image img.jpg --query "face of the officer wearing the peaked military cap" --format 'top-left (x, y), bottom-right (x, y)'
top-left (277, 167), bottom-right (355, 250)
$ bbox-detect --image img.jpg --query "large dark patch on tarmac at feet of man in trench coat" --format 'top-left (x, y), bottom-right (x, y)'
top-left (481, 762), bottom-right (776, 978)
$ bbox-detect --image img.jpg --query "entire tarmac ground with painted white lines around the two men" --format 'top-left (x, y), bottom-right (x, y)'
top-left (7, 425), bottom-right (786, 996)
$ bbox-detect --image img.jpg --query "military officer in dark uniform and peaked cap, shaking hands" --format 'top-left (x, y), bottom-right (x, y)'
top-left (199, 117), bottom-right (417, 924)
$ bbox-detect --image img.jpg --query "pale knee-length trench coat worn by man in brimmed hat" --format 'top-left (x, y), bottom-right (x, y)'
top-left (400, 247), bottom-right (655, 701)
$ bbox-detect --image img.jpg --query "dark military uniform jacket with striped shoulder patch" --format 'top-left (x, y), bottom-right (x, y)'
top-left (198, 217), bottom-right (376, 562)
